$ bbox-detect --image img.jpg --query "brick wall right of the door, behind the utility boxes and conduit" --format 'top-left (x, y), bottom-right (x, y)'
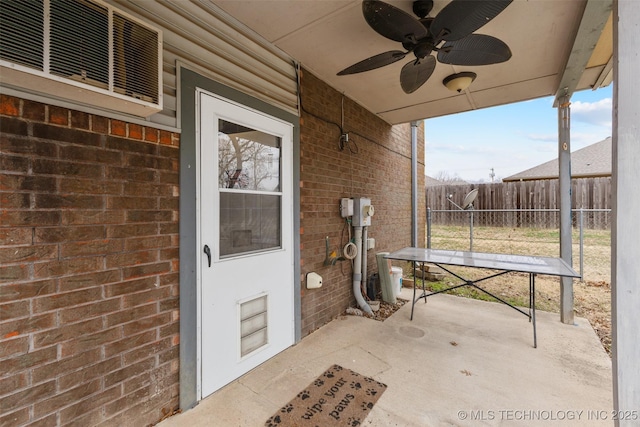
top-left (300, 71), bottom-right (425, 336)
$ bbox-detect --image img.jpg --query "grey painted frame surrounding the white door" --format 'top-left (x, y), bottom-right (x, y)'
top-left (177, 64), bottom-right (302, 410)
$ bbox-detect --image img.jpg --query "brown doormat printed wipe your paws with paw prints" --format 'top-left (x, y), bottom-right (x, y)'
top-left (265, 365), bottom-right (387, 427)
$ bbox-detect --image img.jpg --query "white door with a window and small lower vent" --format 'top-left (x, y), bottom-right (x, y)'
top-left (198, 93), bottom-right (294, 397)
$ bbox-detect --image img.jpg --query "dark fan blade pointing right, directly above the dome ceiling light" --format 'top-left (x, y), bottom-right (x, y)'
top-left (438, 34), bottom-right (511, 66)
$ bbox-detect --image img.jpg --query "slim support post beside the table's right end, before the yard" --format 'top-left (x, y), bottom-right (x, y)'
top-left (558, 96), bottom-right (574, 324)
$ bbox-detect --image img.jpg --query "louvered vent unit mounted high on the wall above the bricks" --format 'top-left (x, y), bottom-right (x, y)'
top-left (0, 0), bottom-right (162, 117)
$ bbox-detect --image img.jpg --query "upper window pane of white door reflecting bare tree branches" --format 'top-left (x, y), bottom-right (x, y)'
top-left (218, 120), bottom-right (281, 191)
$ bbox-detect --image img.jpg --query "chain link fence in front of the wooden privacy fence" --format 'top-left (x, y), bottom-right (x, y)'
top-left (427, 209), bottom-right (611, 284)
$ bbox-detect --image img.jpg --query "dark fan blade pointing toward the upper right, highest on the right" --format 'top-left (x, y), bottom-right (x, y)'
top-left (429, 0), bottom-right (513, 44)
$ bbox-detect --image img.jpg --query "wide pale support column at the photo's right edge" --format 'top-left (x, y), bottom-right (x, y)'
top-left (611, 0), bottom-right (640, 427)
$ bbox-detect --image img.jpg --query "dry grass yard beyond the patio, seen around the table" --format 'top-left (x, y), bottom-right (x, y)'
top-left (412, 226), bottom-right (611, 354)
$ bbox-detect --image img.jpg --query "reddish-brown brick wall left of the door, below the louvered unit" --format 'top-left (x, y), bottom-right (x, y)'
top-left (0, 95), bottom-right (179, 426)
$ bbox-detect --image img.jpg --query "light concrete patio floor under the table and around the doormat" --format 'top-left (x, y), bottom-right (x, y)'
top-left (158, 289), bottom-right (613, 427)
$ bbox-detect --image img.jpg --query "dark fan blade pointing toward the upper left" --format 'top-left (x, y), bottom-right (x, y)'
top-left (362, 0), bottom-right (429, 43)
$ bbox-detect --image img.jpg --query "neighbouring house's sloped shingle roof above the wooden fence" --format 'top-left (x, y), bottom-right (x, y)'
top-left (502, 137), bottom-right (611, 182)
